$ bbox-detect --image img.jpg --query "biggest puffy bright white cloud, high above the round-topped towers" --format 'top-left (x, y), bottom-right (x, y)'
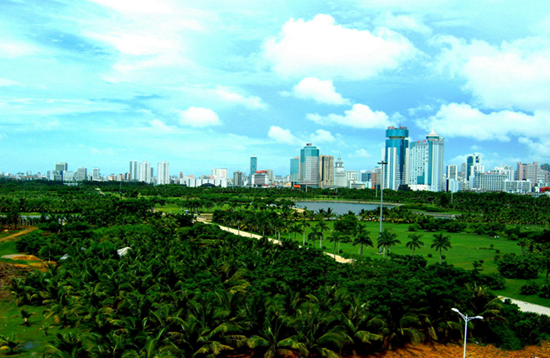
top-left (263, 15), bottom-right (418, 80)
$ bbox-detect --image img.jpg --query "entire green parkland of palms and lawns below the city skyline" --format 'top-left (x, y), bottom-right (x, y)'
top-left (0, 180), bottom-right (550, 358)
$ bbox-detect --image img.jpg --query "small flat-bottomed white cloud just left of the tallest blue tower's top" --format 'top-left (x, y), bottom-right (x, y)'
top-left (306, 103), bottom-right (394, 129)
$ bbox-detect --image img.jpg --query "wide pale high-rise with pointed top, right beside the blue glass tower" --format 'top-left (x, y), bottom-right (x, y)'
top-left (407, 131), bottom-right (445, 191)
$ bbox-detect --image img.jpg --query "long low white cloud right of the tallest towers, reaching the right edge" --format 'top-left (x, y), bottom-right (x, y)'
top-left (416, 103), bottom-right (550, 142)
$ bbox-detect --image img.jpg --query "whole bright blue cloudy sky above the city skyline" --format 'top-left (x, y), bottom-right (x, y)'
top-left (0, 0), bottom-right (550, 175)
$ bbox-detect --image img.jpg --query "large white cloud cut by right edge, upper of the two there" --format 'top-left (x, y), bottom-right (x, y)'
top-left (435, 36), bottom-right (550, 111)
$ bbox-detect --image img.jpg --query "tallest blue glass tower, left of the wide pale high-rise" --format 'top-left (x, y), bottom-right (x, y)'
top-left (384, 127), bottom-right (409, 190)
